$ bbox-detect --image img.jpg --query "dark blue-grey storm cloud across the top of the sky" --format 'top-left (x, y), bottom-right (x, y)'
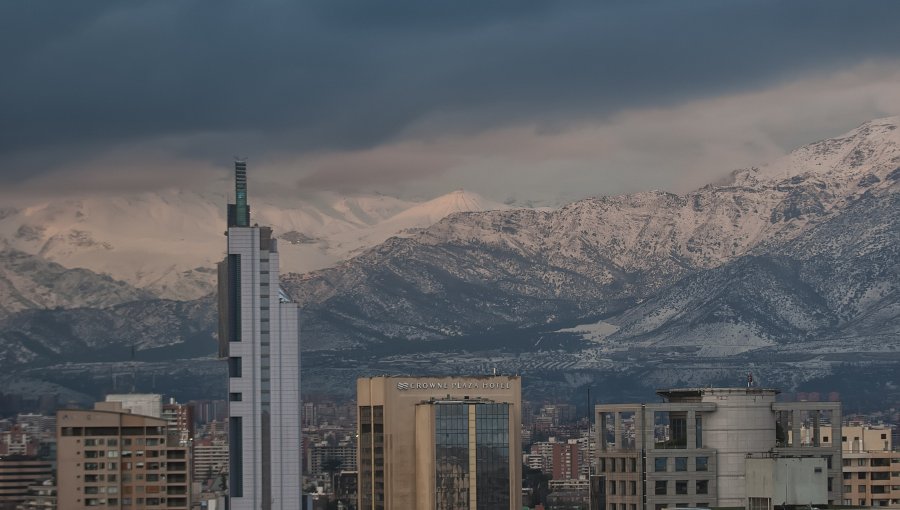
top-left (0, 0), bottom-right (900, 180)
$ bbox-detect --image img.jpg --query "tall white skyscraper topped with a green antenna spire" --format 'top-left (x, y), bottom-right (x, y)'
top-left (218, 161), bottom-right (301, 510)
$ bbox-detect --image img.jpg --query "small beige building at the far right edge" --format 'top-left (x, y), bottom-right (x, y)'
top-left (841, 425), bottom-right (900, 508)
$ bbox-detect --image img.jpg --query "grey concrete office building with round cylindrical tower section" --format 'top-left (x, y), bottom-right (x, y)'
top-left (596, 387), bottom-right (842, 510)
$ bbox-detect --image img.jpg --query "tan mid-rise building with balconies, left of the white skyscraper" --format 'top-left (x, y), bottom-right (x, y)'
top-left (56, 402), bottom-right (191, 510)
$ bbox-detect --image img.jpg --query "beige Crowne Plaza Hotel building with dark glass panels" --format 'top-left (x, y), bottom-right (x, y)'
top-left (357, 376), bottom-right (522, 510)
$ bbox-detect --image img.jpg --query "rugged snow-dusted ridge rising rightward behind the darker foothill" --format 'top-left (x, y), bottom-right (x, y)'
top-left (288, 118), bottom-right (900, 343)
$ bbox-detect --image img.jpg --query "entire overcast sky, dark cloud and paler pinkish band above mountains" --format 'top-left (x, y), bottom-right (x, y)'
top-left (0, 0), bottom-right (900, 203)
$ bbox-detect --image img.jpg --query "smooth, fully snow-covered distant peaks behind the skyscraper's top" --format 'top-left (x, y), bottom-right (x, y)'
top-left (0, 190), bottom-right (507, 298)
